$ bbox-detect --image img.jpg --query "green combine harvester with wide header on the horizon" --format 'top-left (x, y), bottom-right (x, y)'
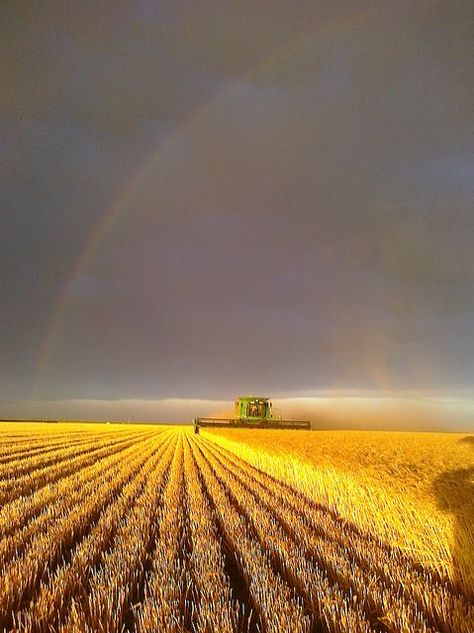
top-left (193, 396), bottom-right (311, 433)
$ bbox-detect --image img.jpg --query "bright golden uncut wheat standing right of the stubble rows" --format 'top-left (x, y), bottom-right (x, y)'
top-left (209, 429), bottom-right (474, 590)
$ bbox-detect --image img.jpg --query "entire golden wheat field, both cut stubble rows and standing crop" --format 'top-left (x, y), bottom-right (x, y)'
top-left (0, 423), bottom-right (474, 633)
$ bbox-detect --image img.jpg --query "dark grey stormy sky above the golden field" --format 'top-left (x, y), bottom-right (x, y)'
top-left (0, 0), bottom-right (474, 428)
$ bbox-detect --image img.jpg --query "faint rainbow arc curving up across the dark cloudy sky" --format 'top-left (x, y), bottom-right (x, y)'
top-left (33, 7), bottom-right (396, 399)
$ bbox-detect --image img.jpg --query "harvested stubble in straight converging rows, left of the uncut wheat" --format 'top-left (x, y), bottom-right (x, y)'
top-left (0, 429), bottom-right (474, 633)
